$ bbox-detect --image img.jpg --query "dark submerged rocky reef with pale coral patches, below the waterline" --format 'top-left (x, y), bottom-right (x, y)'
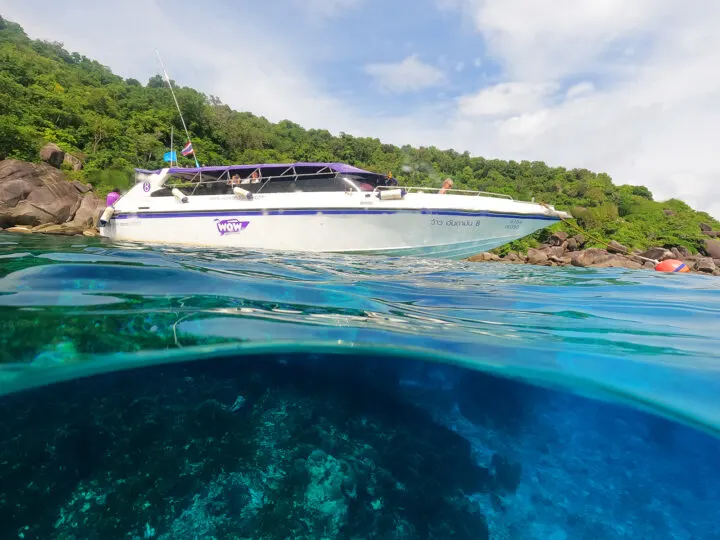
top-left (0, 358), bottom-right (496, 540)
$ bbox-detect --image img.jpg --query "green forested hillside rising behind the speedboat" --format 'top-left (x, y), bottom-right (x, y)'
top-left (0, 18), bottom-right (720, 251)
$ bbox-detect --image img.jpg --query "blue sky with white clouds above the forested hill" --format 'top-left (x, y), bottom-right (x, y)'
top-left (0, 0), bottom-right (720, 218)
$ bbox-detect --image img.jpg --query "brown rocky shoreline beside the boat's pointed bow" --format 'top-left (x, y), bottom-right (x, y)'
top-left (467, 230), bottom-right (720, 276)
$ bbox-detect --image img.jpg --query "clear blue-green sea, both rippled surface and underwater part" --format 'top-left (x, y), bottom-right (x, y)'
top-left (0, 233), bottom-right (720, 540)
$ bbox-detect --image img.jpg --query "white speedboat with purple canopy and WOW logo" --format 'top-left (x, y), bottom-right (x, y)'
top-left (99, 163), bottom-right (570, 259)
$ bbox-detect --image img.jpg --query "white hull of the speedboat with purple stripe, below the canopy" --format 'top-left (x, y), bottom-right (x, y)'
top-left (101, 192), bottom-right (560, 259)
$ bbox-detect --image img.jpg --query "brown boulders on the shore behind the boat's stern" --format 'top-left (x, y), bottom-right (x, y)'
top-left (0, 159), bottom-right (100, 227)
